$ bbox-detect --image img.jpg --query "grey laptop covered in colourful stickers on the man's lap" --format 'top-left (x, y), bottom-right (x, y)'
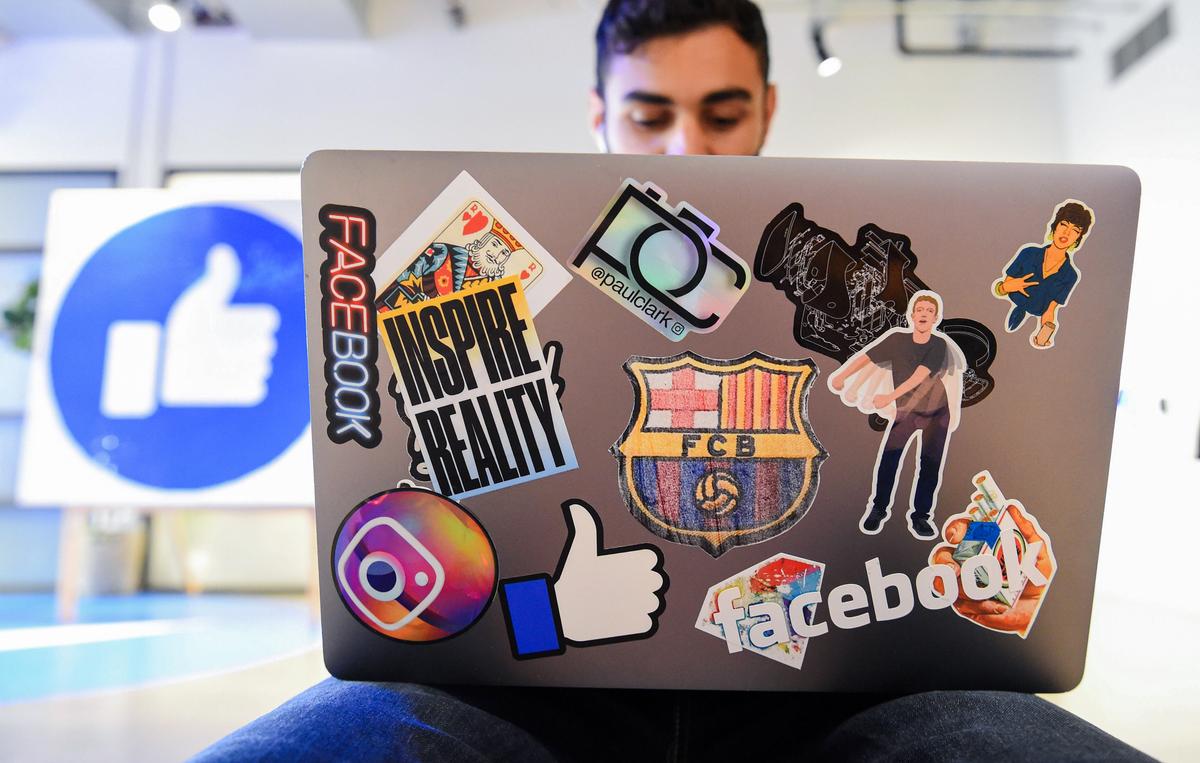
top-left (302, 151), bottom-right (1140, 692)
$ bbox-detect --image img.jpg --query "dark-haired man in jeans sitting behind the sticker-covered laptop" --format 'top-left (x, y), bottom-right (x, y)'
top-left (194, 0), bottom-right (1148, 762)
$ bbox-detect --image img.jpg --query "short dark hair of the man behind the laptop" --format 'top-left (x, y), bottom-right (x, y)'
top-left (596, 0), bottom-right (770, 97)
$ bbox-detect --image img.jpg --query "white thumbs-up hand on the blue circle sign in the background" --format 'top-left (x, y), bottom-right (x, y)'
top-left (101, 244), bottom-right (280, 419)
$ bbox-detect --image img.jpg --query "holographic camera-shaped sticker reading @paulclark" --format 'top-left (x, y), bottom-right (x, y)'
top-left (571, 180), bottom-right (750, 342)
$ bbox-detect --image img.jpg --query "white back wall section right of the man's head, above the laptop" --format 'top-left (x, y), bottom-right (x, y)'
top-left (767, 11), bottom-right (1064, 162)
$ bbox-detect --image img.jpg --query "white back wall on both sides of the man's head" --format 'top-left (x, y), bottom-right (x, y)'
top-left (0, 0), bottom-right (1064, 169)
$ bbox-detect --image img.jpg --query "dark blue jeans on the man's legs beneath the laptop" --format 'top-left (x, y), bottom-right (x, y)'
top-left (194, 678), bottom-right (1151, 763)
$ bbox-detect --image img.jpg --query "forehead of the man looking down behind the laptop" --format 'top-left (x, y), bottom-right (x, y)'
top-left (604, 25), bottom-right (764, 106)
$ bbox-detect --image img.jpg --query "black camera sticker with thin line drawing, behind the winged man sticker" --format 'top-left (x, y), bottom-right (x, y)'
top-left (754, 204), bottom-right (996, 415)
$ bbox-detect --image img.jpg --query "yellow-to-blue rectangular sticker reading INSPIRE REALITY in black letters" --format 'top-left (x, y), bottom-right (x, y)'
top-left (379, 276), bottom-right (576, 498)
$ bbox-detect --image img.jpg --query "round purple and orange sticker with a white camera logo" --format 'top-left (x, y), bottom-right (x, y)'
top-left (334, 488), bottom-right (496, 642)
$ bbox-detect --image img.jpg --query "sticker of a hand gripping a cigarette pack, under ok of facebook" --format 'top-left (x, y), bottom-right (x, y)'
top-left (929, 471), bottom-right (1058, 638)
